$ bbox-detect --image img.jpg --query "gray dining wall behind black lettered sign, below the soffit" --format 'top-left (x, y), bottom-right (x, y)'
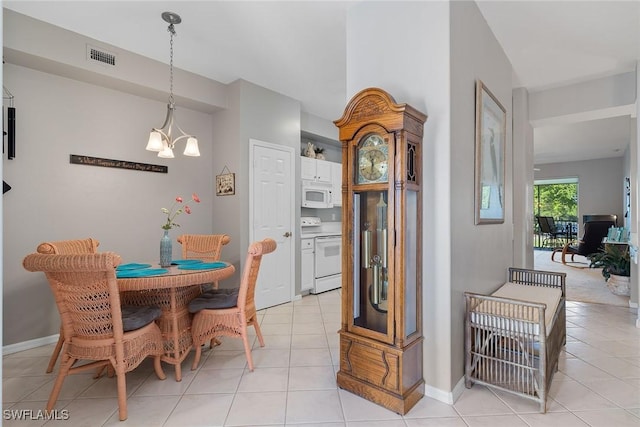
top-left (3, 64), bottom-right (216, 345)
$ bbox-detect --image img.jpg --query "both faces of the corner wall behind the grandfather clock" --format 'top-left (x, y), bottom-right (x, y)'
top-left (347, 2), bottom-right (512, 401)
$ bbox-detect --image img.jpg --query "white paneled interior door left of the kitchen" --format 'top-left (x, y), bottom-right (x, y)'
top-left (249, 139), bottom-right (295, 309)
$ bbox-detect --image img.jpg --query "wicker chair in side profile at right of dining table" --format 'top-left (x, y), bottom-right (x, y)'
top-left (189, 238), bottom-right (277, 371)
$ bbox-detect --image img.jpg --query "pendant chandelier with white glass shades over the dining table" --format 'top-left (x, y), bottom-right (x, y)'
top-left (147, 12), bottom-right (200, 159)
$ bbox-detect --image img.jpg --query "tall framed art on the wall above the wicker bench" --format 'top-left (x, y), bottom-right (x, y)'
top-left (475, 80), bottom-right (507, 224)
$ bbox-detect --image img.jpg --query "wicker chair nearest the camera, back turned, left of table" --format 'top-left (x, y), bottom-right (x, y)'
top-left (23, 252), bottom-right (166, 421)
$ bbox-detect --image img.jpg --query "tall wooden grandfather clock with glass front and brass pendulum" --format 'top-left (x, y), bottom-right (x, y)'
top-left (334, 88), bottom-right (427, 414)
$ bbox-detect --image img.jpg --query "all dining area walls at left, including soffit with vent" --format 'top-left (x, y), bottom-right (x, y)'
top-left (3, 11), bottom-right (308, 345)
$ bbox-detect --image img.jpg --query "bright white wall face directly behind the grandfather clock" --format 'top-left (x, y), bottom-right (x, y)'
top-left (345, 2), bottom-right (452, 400)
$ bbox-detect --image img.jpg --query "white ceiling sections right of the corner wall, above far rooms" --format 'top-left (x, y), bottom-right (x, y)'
top-left (478, 0), bottom-right (640, 164)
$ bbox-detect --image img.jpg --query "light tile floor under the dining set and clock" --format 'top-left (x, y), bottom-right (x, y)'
top-left (2, 290), bottom-right (640, 427)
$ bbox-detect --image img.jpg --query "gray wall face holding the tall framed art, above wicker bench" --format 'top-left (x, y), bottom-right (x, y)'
top-left (450, 2), bottom-right (524, 389)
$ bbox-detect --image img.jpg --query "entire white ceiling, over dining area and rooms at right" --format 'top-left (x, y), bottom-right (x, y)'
top-left (3, 0), bottom-right (640, 163)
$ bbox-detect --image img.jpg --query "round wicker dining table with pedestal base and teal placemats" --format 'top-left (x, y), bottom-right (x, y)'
top-left (118, 263), bottom-right (235, 381)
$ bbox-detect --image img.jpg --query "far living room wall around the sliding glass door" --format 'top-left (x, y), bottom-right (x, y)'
top-left (534, 157), bottom-right (628, 232)
